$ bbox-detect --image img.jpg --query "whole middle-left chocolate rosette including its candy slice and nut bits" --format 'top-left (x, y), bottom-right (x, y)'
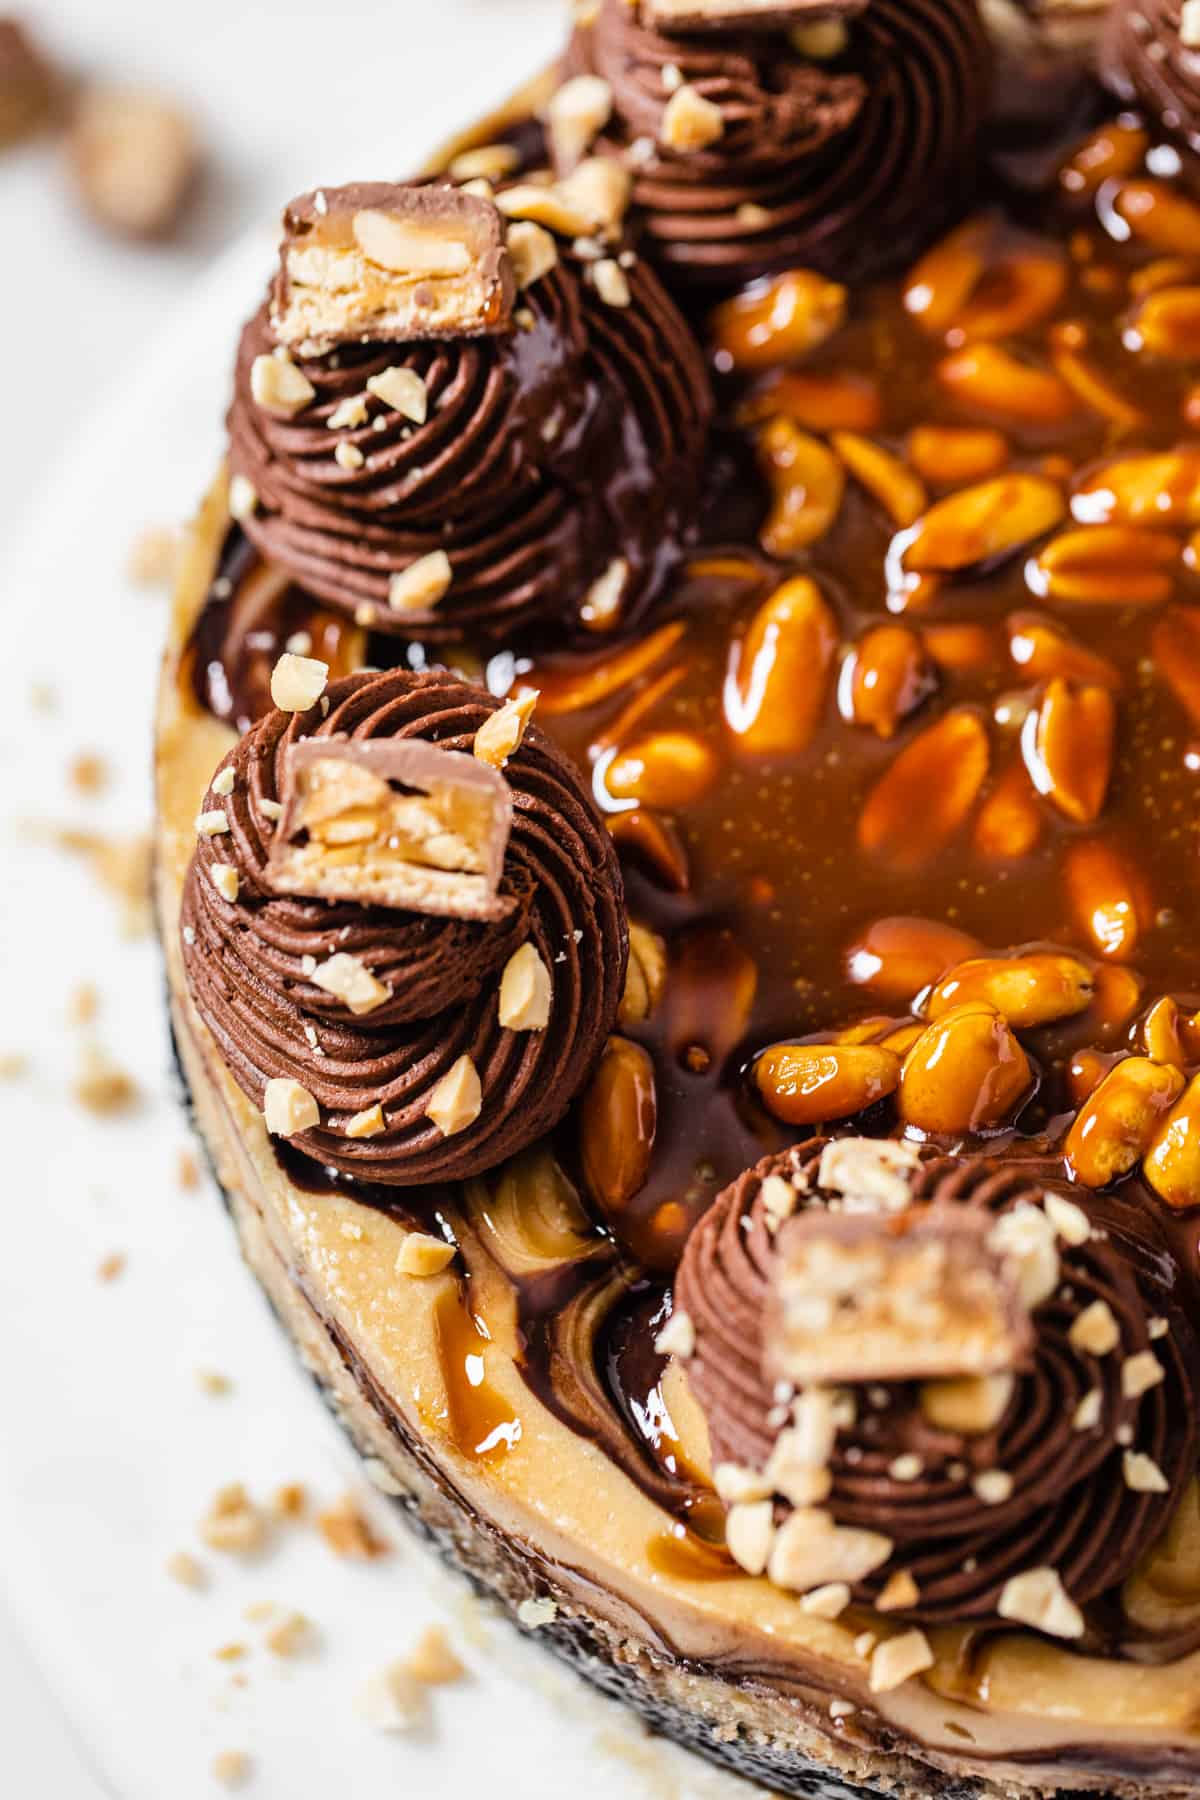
top-left (182, 657), bottom-right (628, 1186)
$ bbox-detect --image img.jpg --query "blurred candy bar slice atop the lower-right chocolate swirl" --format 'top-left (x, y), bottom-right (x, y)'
top-left (763, 1206), bottom-right (1033, 1388)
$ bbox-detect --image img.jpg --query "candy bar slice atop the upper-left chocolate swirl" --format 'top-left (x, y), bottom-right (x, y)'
top-left (272, 182), bottom-right (516, 355)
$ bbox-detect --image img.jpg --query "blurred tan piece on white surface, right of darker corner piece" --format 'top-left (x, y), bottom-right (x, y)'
top-left (67, 88), bottom-right (200, 238)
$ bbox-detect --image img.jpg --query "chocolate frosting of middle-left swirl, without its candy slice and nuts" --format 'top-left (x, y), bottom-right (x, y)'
top-left (182, 671), bottom-right (628, 1186)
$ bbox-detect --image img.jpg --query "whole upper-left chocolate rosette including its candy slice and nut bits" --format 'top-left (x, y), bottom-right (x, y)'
top-left (228, 184), bottom-right (711, 641)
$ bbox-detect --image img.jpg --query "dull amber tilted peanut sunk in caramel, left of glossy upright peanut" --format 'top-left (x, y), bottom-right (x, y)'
top-left (858, 706), bottom-right (990, 869)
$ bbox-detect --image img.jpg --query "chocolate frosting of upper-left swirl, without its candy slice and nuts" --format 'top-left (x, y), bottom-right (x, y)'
top-left (228, 182), bottom-right (712, 643)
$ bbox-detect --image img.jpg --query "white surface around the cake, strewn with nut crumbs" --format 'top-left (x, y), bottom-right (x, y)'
top-left (0, 0), bottom-right (759, 1800)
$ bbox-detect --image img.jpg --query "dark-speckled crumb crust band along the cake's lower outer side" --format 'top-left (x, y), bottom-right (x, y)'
top-left (159, 957), bottom-right (1195, 1800)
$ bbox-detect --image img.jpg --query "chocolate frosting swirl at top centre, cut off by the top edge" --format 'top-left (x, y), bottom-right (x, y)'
top-left (567, 0), bottom-right (990, 288)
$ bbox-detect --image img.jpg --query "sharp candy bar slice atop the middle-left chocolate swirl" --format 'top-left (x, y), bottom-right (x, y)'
top-left (266, 738), bottom-right (513, 920)
